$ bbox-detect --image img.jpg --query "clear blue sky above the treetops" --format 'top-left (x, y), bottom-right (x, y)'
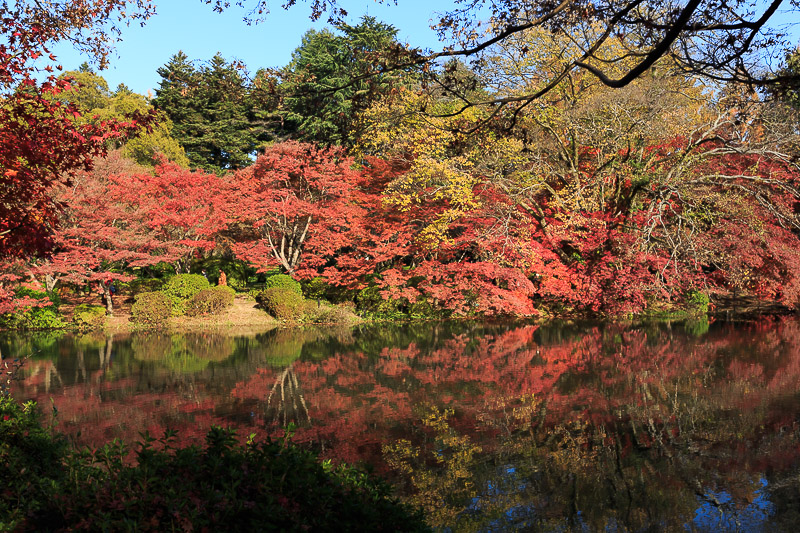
top-left (55, 0), bottom-right (452, 94)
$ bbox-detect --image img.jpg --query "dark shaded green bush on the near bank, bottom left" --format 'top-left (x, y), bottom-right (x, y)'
top-left (0, 397), bottom-right (427, 531)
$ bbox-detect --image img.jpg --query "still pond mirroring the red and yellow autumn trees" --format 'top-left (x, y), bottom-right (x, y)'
top-left (0, 319), bottom-right (800, 531)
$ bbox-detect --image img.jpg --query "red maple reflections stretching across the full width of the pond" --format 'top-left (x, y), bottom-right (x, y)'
top-left (10, 321), bottom-right (800, 482)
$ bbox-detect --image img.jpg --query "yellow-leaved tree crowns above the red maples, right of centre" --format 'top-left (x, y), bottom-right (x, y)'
top-left (356, 21), bottom-right (710, 250)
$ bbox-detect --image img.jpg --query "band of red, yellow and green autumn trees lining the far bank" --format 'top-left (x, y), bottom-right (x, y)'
top-left (0, 1), bottom-right (800, 323)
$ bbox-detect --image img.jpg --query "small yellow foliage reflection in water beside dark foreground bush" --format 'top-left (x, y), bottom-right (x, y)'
top-left (383, 407), bottom-right (481, 527)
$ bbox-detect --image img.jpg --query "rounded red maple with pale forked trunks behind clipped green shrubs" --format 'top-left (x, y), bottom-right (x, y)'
top-left (228, 142), bottom-right (365, 277)
